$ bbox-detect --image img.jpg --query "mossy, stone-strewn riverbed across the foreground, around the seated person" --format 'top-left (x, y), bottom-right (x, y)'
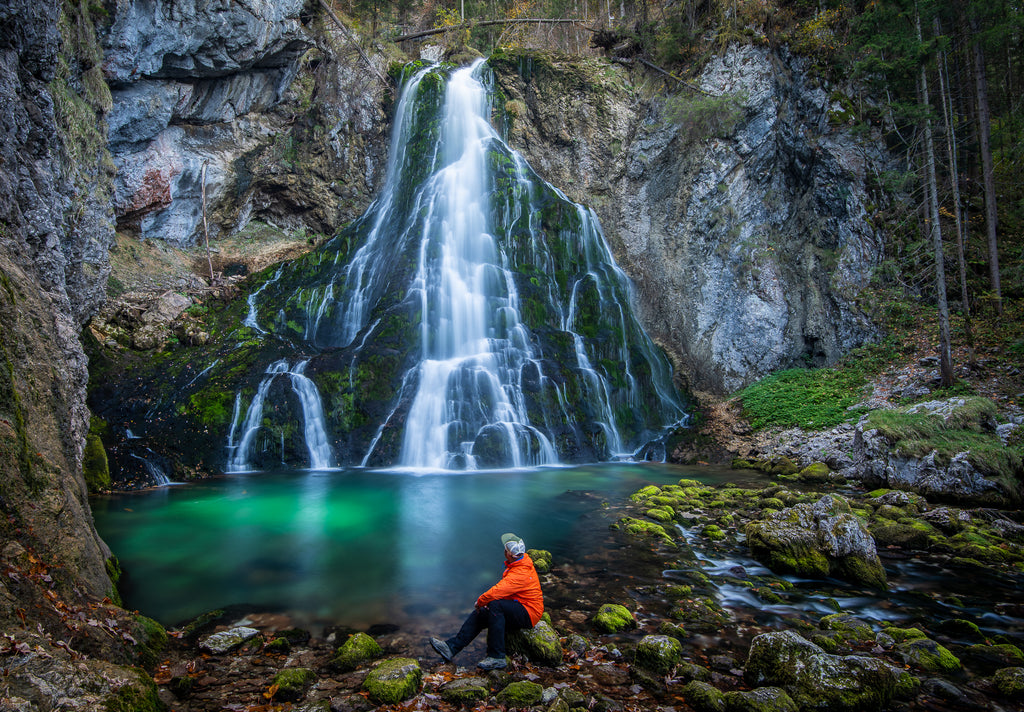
top-left (128, 477), bottom-right (1024, 712)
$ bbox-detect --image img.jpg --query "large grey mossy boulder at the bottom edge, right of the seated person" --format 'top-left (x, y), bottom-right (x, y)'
top-left (743, 630), bottom-right (901, 712)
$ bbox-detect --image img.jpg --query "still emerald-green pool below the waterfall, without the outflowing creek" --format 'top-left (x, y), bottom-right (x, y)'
top-left (92, 463), bottom-right (737, 626)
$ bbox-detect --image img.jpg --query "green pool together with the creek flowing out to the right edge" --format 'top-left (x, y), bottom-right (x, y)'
top-left (93, 463), bottom-right (1024, 644)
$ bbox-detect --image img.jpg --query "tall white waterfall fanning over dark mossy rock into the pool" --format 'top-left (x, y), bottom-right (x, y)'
top-left (227, 60), bottom-right (686, 471)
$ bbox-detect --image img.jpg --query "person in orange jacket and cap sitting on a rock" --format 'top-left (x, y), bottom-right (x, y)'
top-left (430, 533), bottom-right (544, 670)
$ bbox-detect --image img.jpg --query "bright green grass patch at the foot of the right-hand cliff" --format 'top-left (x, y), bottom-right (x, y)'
top-left (738, 368), bottom-right (867, 430)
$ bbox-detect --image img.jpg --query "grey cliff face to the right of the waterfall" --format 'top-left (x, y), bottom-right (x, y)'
top-left (494, 46), bottom-right (887, 392)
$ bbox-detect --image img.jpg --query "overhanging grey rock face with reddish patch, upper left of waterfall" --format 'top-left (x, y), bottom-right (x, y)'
top-left (102, 0), bottom-right (384, 246)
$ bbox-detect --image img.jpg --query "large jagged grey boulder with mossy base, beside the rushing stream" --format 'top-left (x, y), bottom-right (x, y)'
top-left (746, 495), bottom-right (887, 588)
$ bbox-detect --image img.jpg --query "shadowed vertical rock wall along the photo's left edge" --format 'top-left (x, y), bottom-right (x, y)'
top-left (0, 0), bottom-right (113, 602)
